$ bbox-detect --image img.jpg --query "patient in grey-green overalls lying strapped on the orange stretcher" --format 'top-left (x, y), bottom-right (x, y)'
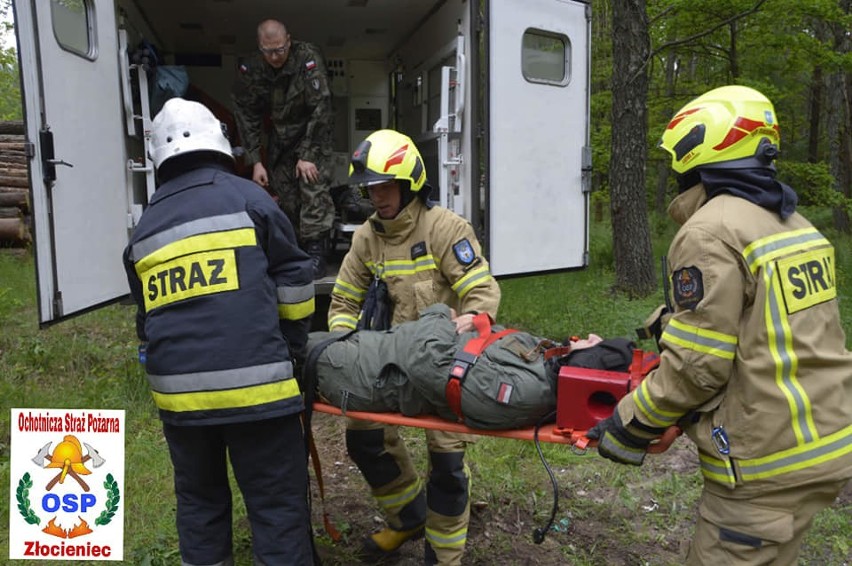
top-left (306, 304), bottom-right (632, 430)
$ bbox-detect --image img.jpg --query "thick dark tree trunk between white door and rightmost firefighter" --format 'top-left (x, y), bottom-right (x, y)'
top-left (610, 0), bottom-right (656, 297)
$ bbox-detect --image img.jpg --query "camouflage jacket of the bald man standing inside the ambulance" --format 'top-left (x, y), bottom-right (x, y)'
top-left (232, 41), bottom-right (334, 167)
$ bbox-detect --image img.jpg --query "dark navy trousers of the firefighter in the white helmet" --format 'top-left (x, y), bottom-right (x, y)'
top-left (163, 414), bottom-right (314, 566)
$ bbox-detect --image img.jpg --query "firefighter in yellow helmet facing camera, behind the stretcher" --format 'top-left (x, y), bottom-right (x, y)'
top-left (328, 130), bottom-right (500, 564)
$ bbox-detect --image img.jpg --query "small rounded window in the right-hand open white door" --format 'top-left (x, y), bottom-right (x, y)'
top-left (521, 29), bottom-right (571, 86)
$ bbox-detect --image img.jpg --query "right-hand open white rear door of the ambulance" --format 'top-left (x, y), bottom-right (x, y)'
top-left (484, 0), bottom-right (591, 276)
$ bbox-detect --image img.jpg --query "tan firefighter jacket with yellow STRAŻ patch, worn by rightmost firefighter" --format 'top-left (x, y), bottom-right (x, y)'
top-left (618, 184), bottom-right (852, 497)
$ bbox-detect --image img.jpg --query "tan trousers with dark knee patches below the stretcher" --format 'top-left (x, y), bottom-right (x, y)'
top-left (346, 419), bottom-right (480, 565)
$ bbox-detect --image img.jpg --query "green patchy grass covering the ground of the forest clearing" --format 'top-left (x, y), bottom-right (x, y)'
top-left (0, 211), bottom-right (852, 566)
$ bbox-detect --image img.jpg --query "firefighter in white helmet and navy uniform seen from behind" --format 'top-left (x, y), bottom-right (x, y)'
top-left (124, 98), bottom-right (314, 566)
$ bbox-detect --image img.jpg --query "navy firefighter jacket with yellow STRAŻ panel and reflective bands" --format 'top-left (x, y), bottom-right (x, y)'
top-left (124, 166), bottom-right (314, 425)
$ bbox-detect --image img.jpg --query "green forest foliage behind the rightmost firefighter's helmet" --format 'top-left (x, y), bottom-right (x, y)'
top-left (591, 0), bottom-right (852, 224)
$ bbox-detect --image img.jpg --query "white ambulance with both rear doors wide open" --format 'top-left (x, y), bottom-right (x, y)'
top-left (13, 0), bottom-right (591, 326)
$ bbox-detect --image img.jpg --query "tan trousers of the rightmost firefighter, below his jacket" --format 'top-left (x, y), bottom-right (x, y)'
top-left (686, 479), bottom-right (847, 566)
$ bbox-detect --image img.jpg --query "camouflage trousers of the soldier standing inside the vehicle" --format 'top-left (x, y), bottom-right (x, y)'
top-left (269, 153), bottom-right (334, 245)
